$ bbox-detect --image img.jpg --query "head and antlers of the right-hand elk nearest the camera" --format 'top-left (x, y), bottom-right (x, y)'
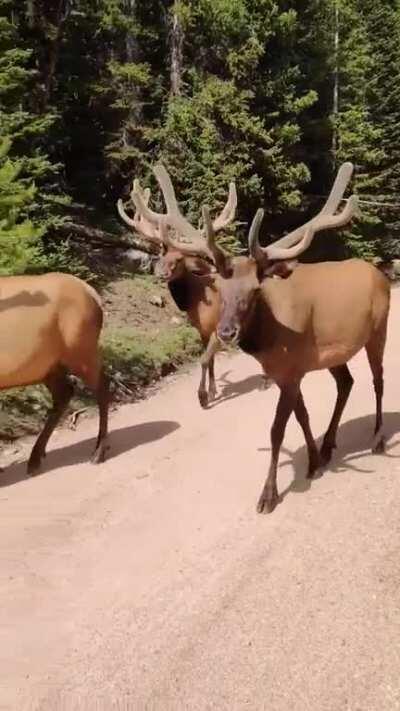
top-left (203, 163), bottom-right (358, 343)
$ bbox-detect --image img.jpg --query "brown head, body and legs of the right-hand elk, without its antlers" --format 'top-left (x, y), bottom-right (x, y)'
top-left (217, 257), bottom-right (390, 511)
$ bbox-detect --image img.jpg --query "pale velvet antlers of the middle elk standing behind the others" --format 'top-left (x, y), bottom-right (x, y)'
top-left (132, 163), bottom-right (237, 258)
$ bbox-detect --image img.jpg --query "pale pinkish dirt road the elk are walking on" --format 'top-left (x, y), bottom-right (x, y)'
top-left (0, 291), bottom-right (400, 711)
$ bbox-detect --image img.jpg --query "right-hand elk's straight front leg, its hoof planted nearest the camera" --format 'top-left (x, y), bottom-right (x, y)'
top-left (257, 383), bottom-right (300, 513)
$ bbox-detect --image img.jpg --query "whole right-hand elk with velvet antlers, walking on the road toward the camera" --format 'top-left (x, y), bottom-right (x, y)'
top-left (135, 163), bottom-right (390, 512)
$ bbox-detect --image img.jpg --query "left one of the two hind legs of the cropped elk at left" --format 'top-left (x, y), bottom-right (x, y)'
top-left (28, 366), bottom-right (74, 476)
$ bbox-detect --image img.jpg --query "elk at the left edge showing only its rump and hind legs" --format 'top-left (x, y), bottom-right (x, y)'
top-left (0, 273), bottom-right (109, 476)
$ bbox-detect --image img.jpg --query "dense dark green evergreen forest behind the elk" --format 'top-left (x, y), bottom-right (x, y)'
top-left (0, 0), bottom-right (400, 274)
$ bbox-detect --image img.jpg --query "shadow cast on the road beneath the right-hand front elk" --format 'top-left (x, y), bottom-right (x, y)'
top-left (260, 412), bottom-right (400, 500)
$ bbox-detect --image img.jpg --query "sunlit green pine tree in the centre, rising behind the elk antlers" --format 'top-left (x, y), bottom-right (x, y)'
top-left (146, 0), bottom-right (316, 250)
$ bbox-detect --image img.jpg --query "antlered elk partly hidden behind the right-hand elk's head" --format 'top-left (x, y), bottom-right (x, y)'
top-left (117, 164), bottom-right (237, 408)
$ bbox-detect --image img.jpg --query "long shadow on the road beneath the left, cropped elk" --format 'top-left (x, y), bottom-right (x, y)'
top-left (0, 420), bottom-right (180, 488)
